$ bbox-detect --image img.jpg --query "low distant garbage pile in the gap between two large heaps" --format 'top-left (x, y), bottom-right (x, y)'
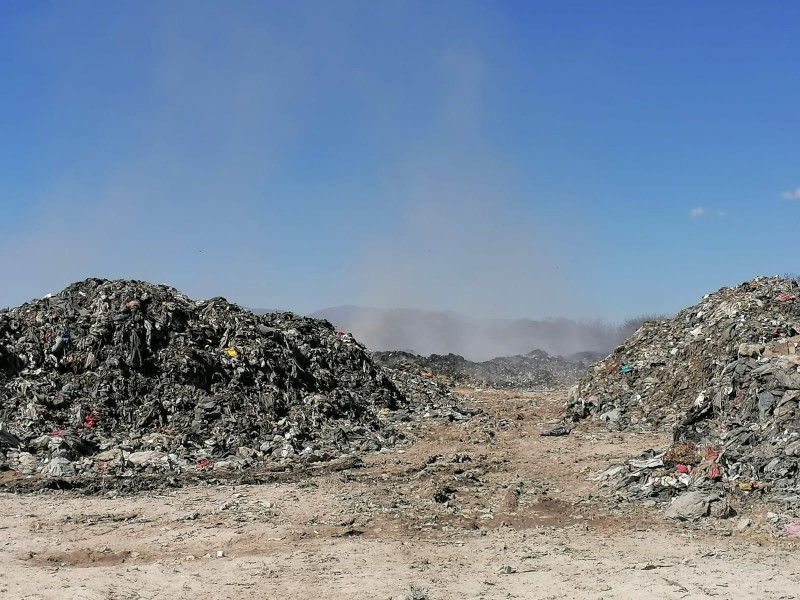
top-left (372, 350), bottom-right (586, 389)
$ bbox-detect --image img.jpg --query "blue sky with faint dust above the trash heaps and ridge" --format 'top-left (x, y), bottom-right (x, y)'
top-left (0, 0), bottom-right (800, 320)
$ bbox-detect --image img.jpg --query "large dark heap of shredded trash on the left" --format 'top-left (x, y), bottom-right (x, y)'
top-left (0, 279), bottom-right (446, 477)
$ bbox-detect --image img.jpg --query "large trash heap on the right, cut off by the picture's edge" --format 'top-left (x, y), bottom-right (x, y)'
top-left (567, 277), bottom-right (800, 505)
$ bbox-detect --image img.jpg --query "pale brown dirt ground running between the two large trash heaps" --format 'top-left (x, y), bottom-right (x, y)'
top-left (0, 390), bottom-right (800, 600)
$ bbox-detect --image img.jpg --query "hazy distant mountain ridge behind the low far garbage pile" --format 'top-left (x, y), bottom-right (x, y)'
top-left (309, 306), bottom-right (624, 361)
